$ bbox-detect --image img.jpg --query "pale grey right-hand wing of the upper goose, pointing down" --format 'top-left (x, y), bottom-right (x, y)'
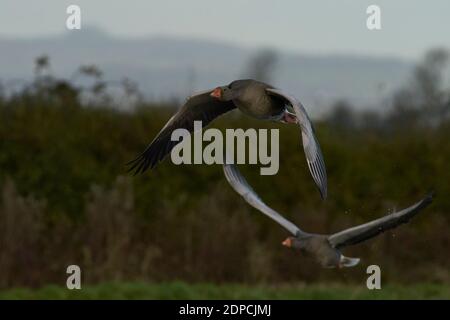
top-left (266, 89), bottom-right (328, 199)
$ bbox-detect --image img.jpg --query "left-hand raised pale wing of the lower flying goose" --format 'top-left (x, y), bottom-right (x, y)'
top-left (223, 164), bottom-right (306, 236)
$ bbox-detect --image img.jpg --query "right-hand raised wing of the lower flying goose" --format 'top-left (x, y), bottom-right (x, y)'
top-left (328, 193), bottom-right (433, 248)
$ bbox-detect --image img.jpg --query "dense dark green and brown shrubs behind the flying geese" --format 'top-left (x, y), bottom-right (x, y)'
top-left (0, 97), bottom-right (450, 287)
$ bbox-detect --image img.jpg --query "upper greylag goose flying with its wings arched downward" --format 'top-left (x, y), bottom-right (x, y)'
top-left (128, 79), bottom-right (327, 199)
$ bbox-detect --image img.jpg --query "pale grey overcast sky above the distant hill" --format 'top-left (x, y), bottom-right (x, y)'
top-left (0, 0), bottom-right (450, 60)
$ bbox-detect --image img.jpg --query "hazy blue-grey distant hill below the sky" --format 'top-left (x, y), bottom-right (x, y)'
top-left (0, 28), bottom-right (412, 115)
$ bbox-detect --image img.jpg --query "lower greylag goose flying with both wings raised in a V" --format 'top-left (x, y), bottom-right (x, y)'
top-left (223, 164), bottom-right (432, 268)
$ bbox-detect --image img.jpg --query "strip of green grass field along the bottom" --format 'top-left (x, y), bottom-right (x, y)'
top-left (0, 282), bottom-right (450, 299)
